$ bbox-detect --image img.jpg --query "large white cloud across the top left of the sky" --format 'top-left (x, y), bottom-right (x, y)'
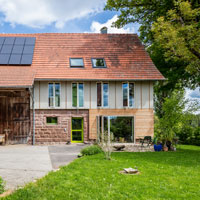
top-left (0, 0), bottom-right (106, 28)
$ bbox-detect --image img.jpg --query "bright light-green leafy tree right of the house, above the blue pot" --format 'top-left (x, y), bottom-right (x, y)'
top-left (155, 90), bottom-right (200, 147)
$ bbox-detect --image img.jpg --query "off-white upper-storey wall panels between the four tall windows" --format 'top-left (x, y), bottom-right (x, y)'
top-left (34, 81), bottom-right (153, 109)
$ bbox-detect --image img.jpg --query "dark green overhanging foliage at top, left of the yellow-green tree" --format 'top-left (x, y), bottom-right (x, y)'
top-left (105, 0), bottom-right (174, 44)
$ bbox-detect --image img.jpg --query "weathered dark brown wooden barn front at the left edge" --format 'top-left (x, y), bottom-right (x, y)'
top-left (0, 89), bottom-right (31, 144)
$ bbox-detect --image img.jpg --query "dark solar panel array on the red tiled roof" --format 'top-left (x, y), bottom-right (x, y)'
top-left (0, 37), bottom-right (36, 65)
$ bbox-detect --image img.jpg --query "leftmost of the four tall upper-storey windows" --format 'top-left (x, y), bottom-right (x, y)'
top-left (49, 83), bottom-right (60, 107)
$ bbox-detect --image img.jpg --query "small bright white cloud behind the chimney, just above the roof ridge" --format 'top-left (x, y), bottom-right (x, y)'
top-left (90, 15), bottom-right (135, 33)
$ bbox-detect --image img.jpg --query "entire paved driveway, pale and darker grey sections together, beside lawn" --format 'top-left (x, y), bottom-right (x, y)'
top-left (0, 144), bottom-right (86, 189)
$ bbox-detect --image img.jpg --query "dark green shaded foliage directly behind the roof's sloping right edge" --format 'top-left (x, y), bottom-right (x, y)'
top-left (147, 42), bottom-right (197, 117)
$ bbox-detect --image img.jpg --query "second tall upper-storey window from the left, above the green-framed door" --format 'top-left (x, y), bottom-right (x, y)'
top-left (72, 83), bottom-right (84, 107)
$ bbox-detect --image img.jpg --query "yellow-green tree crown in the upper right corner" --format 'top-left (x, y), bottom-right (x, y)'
top-left (152, 0), bottom-right (200, 82)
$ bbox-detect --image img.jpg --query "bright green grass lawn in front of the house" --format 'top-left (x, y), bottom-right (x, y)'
top-left (1, 145), bottom-right (200, 200)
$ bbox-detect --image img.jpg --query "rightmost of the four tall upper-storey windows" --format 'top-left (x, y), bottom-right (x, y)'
top-left (122, 83), bottom-right (134, 107)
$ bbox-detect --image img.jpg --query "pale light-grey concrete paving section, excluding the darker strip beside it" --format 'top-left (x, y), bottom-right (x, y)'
top-left (0, 145), bottom-right (52, 189)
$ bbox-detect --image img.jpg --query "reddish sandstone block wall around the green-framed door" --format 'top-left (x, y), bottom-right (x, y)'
top-left (29, 109), bottom-right (89, 144)
